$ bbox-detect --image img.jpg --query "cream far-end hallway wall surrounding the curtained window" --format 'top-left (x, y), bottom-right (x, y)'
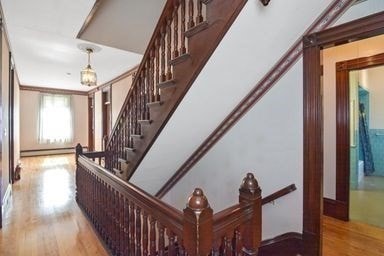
top-left (20, 90), bottom-right (88, 151)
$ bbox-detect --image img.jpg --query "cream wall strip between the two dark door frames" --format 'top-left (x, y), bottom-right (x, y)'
top-left (323, 35), bottom-right (384, 199)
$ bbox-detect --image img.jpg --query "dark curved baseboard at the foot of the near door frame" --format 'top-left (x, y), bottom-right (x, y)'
top-left (258, 232), bottom-right (303, 256)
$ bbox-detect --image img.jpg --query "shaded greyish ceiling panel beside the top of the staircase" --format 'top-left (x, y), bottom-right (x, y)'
top-left (80, 0), bottom-right (166, 54)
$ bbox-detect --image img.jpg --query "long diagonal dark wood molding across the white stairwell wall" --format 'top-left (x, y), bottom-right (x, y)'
top-left (156, 0), bottom-right (353, 198)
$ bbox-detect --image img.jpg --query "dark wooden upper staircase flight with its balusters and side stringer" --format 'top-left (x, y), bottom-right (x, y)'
top-left (106, 0), bottom-right (247, 180)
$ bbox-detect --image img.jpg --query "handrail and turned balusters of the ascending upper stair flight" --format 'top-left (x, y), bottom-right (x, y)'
top-left (106, 0), bottom-right (208, 174)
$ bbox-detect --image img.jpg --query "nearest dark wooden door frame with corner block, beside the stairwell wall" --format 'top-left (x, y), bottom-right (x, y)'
top-left (303, 12), bottom-right (384, 255)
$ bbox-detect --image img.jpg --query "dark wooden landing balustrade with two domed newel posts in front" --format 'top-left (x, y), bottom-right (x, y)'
top-left (76, 147), bottom-right (261, 256)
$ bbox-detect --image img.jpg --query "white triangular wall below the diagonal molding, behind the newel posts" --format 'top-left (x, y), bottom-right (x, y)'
top-left (164, 61), bottom-right (303, 239)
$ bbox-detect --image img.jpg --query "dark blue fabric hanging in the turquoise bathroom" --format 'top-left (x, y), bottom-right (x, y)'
top-left (359, 103), bottom-right (375, 175)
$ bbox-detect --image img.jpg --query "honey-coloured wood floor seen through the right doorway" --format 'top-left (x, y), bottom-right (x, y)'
top-left (323, 217), bottom-right (384, 256)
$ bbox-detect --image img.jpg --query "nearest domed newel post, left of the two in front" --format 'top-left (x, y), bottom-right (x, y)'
top-left (183, 188), bottom-right (213, 256)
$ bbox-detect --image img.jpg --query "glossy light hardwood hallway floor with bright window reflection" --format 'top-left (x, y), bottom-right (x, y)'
top-left (0, 155), bottom-right (108, 256)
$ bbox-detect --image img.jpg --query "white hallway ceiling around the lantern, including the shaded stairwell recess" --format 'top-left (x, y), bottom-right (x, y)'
top-left (1, 0), bottom-right (165, 91)
